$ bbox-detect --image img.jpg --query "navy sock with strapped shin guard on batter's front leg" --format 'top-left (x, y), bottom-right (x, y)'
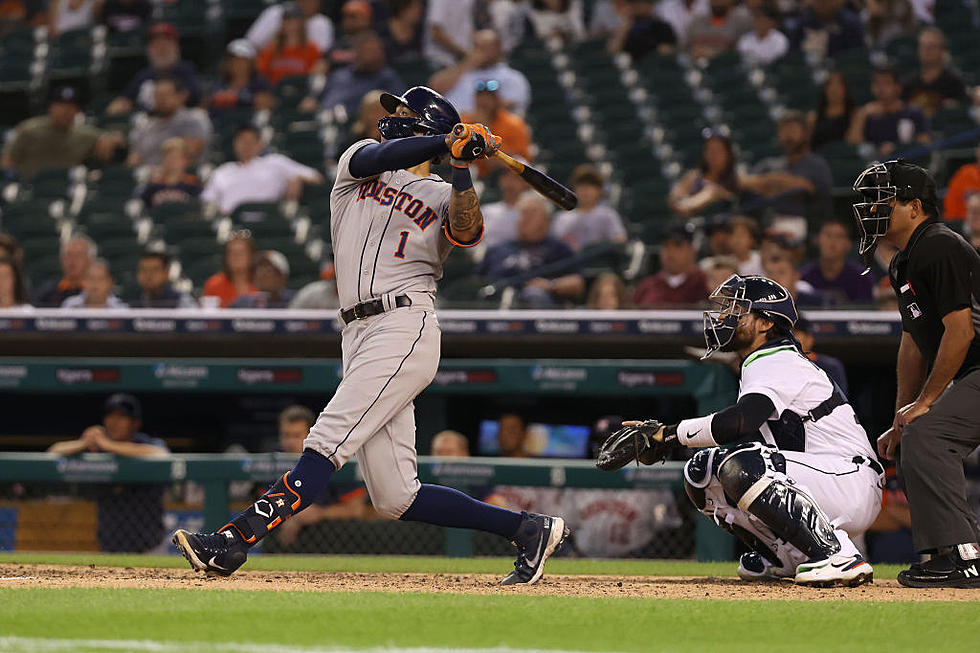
top-left (224, 449), bottom-right (336, 546)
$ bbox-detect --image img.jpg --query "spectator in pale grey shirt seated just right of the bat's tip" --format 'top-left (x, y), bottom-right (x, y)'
top-left (556, 164), bottom-right (626, 251)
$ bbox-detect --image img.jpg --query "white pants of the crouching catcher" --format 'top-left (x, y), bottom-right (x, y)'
top-left (685, 443), bottom-right (882, 569)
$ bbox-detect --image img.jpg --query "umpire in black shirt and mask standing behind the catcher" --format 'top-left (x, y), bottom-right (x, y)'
top-left (854, 160), bottom-right (980, 588)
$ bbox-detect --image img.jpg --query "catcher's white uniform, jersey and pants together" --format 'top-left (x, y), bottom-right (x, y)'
top-left (684, 343), bottom-right (882, 569)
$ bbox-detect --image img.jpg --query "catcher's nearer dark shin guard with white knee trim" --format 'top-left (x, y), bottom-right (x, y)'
top-left (718, 448), bottom-right (840, 560)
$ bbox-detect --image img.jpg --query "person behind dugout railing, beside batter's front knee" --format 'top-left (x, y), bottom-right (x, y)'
top-left (263, 405), bottom-right (368, 546)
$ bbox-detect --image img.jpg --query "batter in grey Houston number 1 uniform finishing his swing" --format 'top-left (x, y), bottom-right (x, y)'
top-left (174, 86), bottom-right (567, 585)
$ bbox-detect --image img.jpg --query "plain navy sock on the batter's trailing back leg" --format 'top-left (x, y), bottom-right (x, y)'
top-left (401, 483), bottom-right (523, 539)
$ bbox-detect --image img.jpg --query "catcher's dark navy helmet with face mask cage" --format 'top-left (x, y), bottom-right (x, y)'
top-left (702, 274), bottom-right (799, 360)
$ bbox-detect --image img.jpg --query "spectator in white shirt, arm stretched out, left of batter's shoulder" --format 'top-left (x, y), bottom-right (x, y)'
top-left (201, 125), bottom-right (323, 213)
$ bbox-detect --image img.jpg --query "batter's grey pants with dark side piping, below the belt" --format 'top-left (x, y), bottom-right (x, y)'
top-left (303, 293), bottom-right (441, 519)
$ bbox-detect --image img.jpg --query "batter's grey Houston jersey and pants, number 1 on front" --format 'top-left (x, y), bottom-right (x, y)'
top-left (303, 139), bottom-right (478, 518)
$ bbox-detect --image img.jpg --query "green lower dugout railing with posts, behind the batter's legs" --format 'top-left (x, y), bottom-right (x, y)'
top-left (0, 453), bottom-right (734, 560)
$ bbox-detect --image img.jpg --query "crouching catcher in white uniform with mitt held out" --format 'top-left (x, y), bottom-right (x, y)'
top-left (597, 275), bottom-right (883, 587)
